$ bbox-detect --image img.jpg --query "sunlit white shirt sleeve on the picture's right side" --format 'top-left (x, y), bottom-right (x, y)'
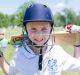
top-left (63, 49), bottom-right (80, 71)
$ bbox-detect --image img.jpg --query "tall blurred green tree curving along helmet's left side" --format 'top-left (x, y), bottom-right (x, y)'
top-left (16, 0), bottom-right (34, 26)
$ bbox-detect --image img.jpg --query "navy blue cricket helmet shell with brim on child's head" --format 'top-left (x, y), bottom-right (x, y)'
top-left (23, 4), bottom-right (54, 27)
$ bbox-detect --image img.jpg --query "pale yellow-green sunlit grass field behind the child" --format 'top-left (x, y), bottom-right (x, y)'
top-left (0, 28), bottom-right (80, 75)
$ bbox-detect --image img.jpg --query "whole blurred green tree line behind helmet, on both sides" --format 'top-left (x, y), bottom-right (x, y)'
top-left (0, 1), bottom-right (80, 28)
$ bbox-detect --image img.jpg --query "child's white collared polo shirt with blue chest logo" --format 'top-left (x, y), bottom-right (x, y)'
top-left (9, 42), bottom-right (80, 75)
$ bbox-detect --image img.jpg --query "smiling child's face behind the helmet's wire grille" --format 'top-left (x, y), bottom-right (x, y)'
top-left (26, 22), bottom-right (51, 45)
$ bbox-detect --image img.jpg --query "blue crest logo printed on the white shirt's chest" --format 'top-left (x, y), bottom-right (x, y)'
top-left (48, 59), bottom-right (58, 73)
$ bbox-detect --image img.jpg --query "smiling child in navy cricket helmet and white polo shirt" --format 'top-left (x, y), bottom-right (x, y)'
top-left (0, 4), bottom-right (80, 75)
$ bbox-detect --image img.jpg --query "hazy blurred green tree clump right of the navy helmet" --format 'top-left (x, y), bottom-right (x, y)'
top-left (54, 8), bottom-right (80, 27)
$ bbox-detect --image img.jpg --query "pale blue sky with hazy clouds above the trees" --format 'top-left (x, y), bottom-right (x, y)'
top-left (0, 0), bottom-right (80, 15)
